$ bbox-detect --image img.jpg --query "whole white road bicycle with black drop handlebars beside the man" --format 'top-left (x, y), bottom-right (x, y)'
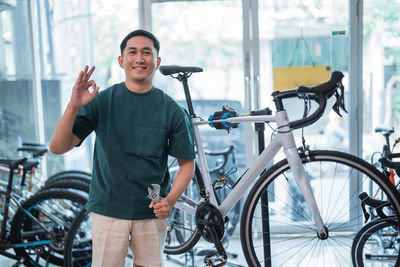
top-left (160, 66), bottom-right (400, 267)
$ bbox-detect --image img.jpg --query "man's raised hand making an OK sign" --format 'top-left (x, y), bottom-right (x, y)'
top-left (69, 66), bottom-right (99, 109)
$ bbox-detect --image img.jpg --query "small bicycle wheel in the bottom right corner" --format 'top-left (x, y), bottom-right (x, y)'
top-left (352, 219), bottom-right (400, 267)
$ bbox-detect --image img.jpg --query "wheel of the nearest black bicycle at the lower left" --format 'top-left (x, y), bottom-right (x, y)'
top-left (10, 189), bottom-right (87, 266)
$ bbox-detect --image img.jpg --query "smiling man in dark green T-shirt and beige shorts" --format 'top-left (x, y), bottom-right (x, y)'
top-left (50, 30), bottom-right (195, 267)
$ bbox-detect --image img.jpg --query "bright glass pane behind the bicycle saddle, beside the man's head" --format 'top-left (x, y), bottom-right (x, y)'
top-left (152, 1), bottom-right (244, 102)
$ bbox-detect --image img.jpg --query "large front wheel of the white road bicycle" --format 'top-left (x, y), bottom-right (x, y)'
top-left (240, 151), bottom-right (400, 266)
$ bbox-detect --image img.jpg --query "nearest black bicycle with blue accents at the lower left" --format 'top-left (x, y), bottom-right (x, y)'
top-left (0, 157), bottom-right (87, 266)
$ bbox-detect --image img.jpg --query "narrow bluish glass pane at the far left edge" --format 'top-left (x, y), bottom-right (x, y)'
top-left (0, 1), bottom-right (36, 157)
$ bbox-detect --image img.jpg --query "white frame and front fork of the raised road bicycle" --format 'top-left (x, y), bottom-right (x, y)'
top-left (175, 110), bottom-right (326, 239)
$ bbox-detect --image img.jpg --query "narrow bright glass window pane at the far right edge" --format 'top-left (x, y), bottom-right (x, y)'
top-left (363, 0), bottom-right (400, 160)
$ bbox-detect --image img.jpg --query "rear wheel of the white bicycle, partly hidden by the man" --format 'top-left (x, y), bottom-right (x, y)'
top-left (164, 164), bottom-right (204, 255)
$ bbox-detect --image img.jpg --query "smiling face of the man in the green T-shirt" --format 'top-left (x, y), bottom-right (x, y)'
top-left (118, 35), bottom-right (161, 92)
